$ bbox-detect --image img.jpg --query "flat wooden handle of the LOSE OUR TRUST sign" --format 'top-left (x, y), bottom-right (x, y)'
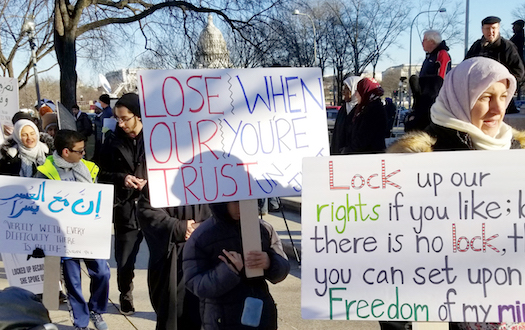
top-left (239, 199), bottom-right (264, 278)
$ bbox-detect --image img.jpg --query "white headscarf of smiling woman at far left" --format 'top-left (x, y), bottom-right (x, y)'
top-left (13, 119), bottom-right (49, 178)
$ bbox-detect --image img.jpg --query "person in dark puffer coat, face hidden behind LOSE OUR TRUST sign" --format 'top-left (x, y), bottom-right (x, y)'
top-left (183, 202), bottom-right (290, 329)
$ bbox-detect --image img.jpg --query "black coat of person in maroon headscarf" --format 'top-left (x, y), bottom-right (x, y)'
top-left (342, 99), bottom-right (387, 154)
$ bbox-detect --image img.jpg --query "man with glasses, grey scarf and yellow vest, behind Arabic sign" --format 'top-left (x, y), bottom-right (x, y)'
top-left (36, 129), bottom-right (110, 330)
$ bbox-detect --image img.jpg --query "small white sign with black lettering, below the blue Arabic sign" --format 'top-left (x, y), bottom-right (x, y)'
top-left (2, 253), bottom-right (44, 294)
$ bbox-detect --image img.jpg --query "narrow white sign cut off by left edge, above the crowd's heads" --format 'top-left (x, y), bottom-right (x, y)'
top-left (0, 77), bottom-right (18, 143)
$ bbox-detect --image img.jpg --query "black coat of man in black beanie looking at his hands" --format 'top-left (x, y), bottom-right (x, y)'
top-left (98, 126), bottom-right (146, 229)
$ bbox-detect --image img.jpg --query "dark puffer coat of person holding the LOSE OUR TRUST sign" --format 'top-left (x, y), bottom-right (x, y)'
top-left (183, 217), bottom-right (290, 330)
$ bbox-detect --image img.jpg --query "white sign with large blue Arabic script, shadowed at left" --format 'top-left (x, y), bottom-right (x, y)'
top-left (0, 176), bottom-right (113, 259)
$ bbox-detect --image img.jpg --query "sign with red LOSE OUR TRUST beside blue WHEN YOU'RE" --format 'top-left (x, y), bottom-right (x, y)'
top-left (138, 68), bottom-right (329, 207)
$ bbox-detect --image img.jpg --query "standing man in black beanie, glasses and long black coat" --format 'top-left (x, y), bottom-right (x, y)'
top-left (100, 93), bottom-right (146, 315)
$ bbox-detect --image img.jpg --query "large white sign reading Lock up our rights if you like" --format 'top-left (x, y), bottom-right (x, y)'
top-left (301, 150), bottom-right (525, 322)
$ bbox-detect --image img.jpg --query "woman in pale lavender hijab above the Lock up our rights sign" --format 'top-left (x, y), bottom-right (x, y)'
top-left (388, 57), bottom-right (525, 152)
